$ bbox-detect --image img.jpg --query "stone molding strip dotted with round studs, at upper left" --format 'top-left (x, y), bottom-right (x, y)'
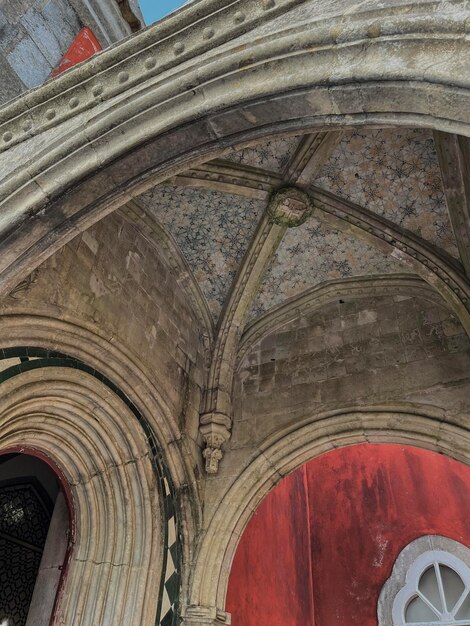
top-left (0, 0), bottom-right (302, 151)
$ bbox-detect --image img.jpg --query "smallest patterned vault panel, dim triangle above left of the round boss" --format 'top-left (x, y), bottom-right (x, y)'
top-left (224, 137), bottom-right (300, 174)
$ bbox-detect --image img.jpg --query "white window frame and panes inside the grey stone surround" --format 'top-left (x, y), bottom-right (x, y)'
top-left (393, 550), bottom-right (470, 626)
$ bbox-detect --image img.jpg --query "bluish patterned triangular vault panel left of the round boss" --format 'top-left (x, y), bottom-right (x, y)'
top-left (139, 184), bottom-right (265, 319)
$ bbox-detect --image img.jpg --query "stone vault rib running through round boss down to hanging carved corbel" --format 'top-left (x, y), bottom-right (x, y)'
top-left (199, 133), bottom-right (340, 474)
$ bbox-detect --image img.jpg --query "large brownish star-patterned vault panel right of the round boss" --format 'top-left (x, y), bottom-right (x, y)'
top-left (315, 128), bottom-right (458, 258)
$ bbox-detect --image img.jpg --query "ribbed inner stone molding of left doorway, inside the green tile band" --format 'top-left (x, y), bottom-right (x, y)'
top-left (0, 367), bottom-right (163, 626)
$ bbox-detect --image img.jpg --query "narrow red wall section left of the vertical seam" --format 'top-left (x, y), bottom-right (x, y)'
top-left (227, 469), bottom-right (313, 626)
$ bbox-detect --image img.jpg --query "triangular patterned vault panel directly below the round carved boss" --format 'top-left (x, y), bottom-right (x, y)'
top-left (249, 218), bottom-right (406, 321)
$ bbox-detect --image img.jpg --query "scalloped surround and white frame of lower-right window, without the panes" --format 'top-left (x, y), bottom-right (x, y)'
top-left (377, 535), bottom-right (470, 626)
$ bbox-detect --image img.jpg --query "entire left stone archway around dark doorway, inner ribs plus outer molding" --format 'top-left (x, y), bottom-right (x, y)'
top-left (0, 315), bottom-right (199, 626)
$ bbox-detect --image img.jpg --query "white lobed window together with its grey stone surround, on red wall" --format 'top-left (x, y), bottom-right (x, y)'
top-left (378, 535), bottom-right (470, 626)
